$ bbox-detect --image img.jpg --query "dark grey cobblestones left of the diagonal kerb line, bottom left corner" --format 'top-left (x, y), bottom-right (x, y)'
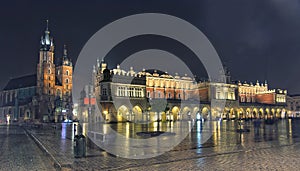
top-left (0, 125), bottom-right (55, 171)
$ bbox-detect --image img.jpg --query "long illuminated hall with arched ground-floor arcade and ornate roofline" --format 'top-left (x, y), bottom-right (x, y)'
top-left (93, 60), bottom-right (287, 122)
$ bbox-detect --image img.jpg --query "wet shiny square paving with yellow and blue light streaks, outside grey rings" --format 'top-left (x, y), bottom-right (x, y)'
top-left (19, 119), bottom-right (300, 170)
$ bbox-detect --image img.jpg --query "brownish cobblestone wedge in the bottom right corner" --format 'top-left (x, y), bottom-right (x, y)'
top-left (127, 144), bottom-right (300, 171)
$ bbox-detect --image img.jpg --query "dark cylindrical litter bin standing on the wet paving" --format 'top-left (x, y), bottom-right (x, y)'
top-left (74, 134), bottom-right (86, 158)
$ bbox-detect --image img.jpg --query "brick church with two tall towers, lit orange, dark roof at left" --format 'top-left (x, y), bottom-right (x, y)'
top-left (0, 21), bottom-right (73, 122)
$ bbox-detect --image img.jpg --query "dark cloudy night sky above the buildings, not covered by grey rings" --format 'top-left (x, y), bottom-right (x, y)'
top-left (0, 0), bottom-right (300, 94)
